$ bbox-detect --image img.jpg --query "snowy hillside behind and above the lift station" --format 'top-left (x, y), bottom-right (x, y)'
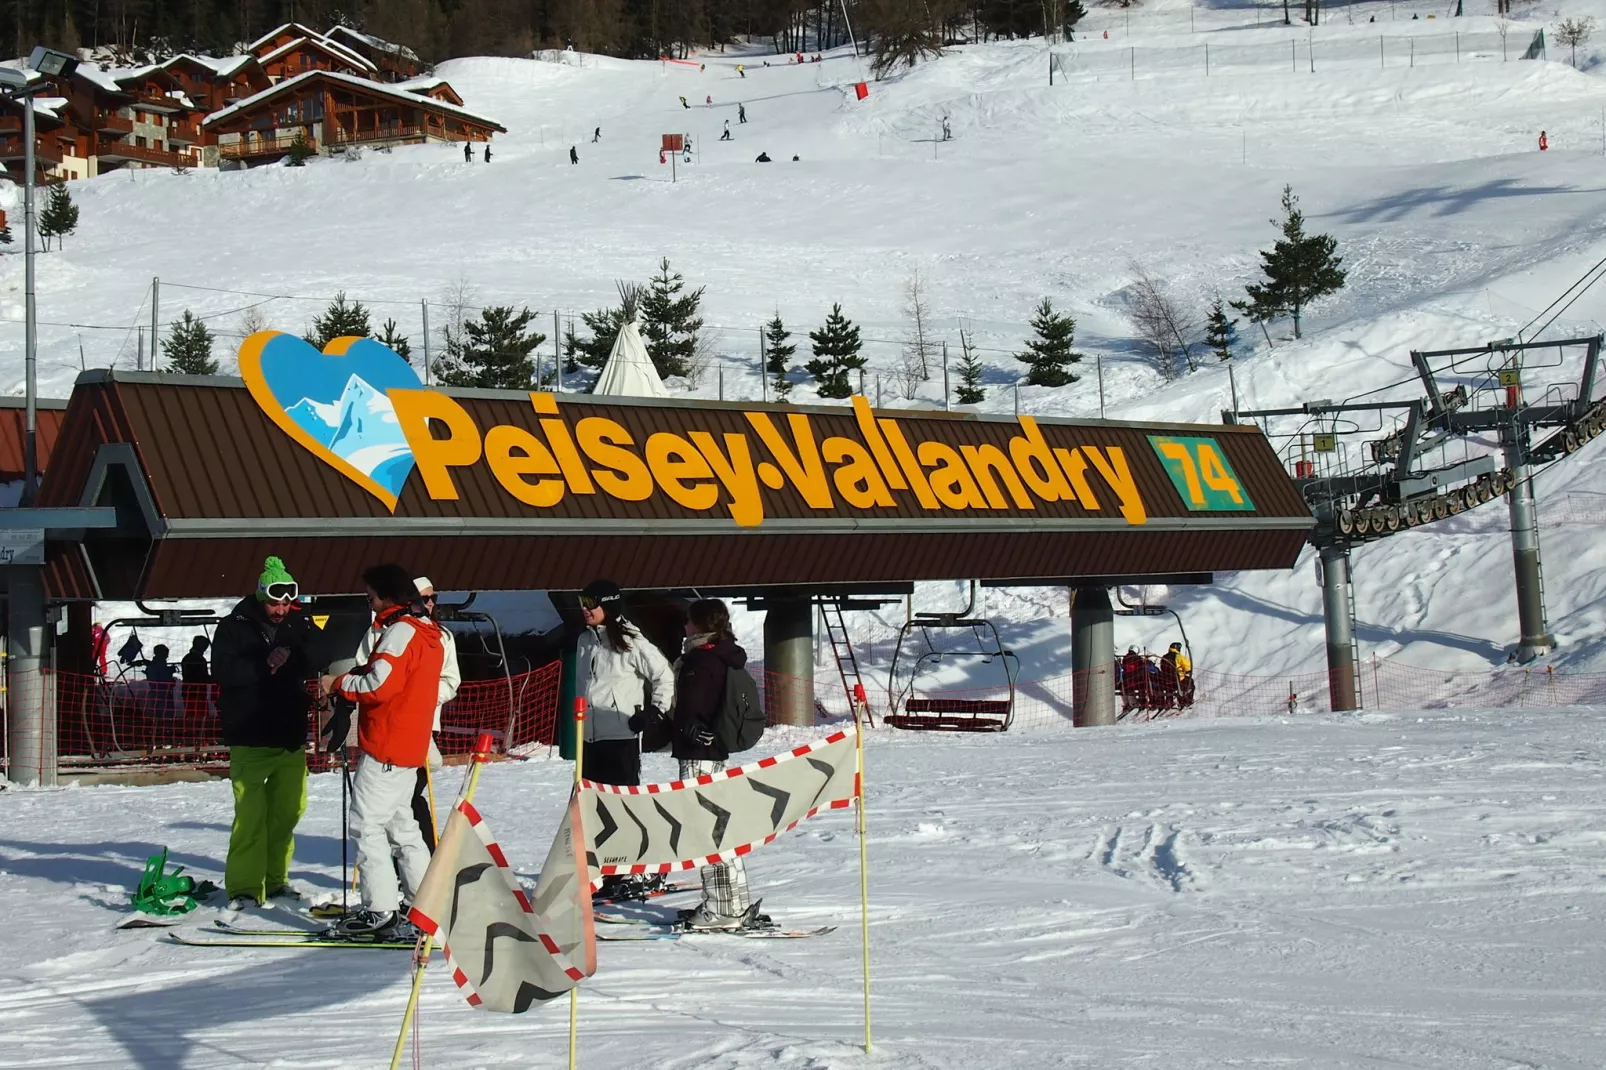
top-left (9, 3), bottom-right (1606, 678)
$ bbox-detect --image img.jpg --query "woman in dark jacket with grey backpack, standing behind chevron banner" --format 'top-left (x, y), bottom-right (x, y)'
top-left (671, 598), bottom-right (758, 929)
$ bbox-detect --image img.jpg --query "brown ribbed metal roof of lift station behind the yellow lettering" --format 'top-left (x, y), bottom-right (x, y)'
top-left (40, 373), bottom-right (1310, 598)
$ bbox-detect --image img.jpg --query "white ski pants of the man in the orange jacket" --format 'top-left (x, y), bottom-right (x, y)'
top-left (352, 753), bottom-right (429, 911)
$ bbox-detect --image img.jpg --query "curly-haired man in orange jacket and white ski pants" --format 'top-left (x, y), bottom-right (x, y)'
top-left (323, 564), bottom-right (445, 940)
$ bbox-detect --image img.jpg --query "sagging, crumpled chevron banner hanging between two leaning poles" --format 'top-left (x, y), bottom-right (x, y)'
top-left (408, 797), bottom-right (597, 1014)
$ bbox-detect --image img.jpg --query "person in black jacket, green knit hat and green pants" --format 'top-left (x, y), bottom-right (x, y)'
top-left (212, 557), bottom-right (313, 909)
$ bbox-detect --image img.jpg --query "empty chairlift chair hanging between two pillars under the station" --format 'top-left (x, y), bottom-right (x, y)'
top-left (882, 594), bottom-right (1020, 733)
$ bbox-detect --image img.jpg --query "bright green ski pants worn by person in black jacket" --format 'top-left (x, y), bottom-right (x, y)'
top-left (223, 747), bottom-right (307, 903)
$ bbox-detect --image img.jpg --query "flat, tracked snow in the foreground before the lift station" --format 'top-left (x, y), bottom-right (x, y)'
top-left (0, 710), bottom-right (1606, 1070)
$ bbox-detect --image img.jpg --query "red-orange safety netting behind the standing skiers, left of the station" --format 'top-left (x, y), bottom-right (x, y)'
top-left (37, 662), bottom-right (562, 768)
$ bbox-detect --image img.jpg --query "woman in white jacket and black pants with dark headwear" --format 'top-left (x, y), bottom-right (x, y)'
top-left (575, 580), bottom-right (675, 898)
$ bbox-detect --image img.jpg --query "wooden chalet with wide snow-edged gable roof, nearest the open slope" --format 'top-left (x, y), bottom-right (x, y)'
top-left (206, 71), bottom-right (506, 167)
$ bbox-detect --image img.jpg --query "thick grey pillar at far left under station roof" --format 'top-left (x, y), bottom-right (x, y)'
top-left (5, 566), bottom-right (56, 787)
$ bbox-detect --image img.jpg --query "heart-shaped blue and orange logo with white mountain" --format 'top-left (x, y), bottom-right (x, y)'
top-left (239, 331), bottom-right (424, 513)
